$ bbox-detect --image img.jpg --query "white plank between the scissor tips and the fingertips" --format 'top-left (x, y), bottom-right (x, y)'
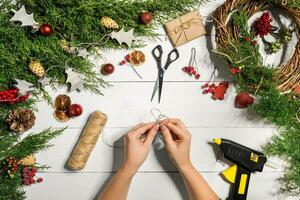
top-left (36, 82), bottom-right (267, 128)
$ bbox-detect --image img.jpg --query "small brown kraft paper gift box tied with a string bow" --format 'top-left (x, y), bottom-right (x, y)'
top-left (164, 11), bottom-right (206, 47)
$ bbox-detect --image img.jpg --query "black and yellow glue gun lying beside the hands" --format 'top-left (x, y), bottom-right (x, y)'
top-left (214, 138), bottom-right (267, 200)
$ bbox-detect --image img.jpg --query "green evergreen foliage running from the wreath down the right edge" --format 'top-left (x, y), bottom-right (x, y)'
top-left (217, 12), bottom-right (300, 196)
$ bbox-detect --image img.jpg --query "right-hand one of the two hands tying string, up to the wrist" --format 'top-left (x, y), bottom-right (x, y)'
top-left (160, 119), bottom-right (192, 169)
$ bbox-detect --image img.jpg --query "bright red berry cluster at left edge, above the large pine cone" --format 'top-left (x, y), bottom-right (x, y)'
top-left (0, 89), bottom-right (29, 105)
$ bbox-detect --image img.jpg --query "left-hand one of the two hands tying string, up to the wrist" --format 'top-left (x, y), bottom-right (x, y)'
top-left (123, 123), bottom-right (159, 174)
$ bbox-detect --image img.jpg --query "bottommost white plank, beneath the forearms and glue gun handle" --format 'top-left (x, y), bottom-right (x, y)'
top-left (26, 172), bottom-right (296, 200)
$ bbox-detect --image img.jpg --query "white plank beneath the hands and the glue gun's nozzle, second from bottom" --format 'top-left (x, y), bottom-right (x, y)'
top-left (29, 128), bottom-right (283, 172)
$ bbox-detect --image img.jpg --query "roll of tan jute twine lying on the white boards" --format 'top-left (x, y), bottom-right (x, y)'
top-left (67, 111), bottom-right (107, 170)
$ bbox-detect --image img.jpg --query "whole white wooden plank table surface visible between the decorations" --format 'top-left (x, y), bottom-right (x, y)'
top-left (26, 1), bottom-right (298, 200)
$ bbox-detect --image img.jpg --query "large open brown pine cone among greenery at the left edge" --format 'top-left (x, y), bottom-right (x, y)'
top-left (6, 108), bottom-right (35, 132)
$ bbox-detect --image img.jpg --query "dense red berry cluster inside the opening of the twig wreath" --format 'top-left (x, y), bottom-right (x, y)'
top-left (254, 12), bottom-right (272, 37)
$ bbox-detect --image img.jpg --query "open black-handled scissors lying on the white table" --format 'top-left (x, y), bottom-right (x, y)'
top-left (151, 45), bottom-right (179, 103)
